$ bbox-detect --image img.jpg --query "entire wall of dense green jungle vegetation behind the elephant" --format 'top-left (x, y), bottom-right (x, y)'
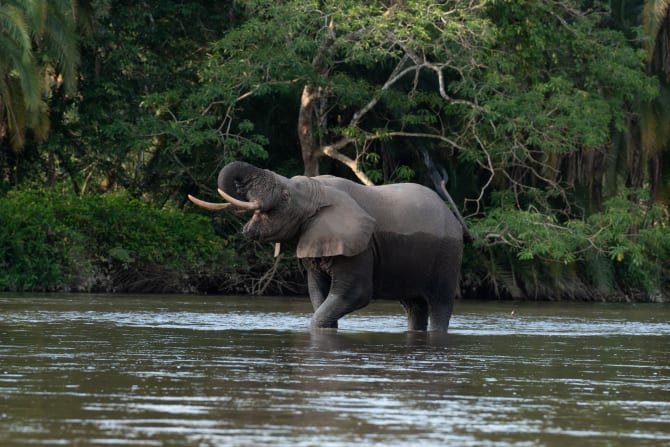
top-left (0, 0), bottom-right (670, 301)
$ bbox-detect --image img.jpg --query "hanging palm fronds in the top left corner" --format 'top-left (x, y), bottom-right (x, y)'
top-left (0, 0), bottom-right (79, 151)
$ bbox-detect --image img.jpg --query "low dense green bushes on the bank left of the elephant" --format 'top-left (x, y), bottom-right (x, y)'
top-left (0, 190), bottom-right (235, 291)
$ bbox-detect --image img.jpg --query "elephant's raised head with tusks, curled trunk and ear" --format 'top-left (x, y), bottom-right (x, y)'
top-left (189, 161), bottom-right (375, 258)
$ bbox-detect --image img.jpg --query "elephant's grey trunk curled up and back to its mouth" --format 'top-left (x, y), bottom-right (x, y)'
top-left (218, 161), bottom-right (281, 211)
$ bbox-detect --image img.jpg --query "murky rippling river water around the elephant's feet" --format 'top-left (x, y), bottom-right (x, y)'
top-left (0, 296), bottom-right (670, 447)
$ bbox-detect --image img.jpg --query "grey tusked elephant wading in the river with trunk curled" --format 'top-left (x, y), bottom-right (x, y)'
top-left (188, 161), bottom-right (469, 333)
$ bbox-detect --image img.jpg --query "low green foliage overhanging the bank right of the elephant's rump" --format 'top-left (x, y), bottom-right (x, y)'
top-left (468, 191), bottom-right (670, 300)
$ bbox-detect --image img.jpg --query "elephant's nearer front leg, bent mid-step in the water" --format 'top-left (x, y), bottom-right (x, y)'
top-left (312, 249), bottom-right (373, 328)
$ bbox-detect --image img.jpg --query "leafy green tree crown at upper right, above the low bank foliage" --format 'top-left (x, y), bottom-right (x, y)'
top-left (454, 0), bottom-right (658, 215)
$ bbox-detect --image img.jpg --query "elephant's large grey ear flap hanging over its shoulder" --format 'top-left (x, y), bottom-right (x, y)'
top-left (296, 186), bottom-right (375, 258)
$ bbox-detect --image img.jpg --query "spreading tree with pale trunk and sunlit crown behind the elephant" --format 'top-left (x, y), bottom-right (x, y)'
top-left (186, 1), bottom-right (488, 183)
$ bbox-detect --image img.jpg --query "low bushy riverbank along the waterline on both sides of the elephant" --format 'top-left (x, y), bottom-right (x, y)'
top-left (0, 191), bottom-right (670, 302)
